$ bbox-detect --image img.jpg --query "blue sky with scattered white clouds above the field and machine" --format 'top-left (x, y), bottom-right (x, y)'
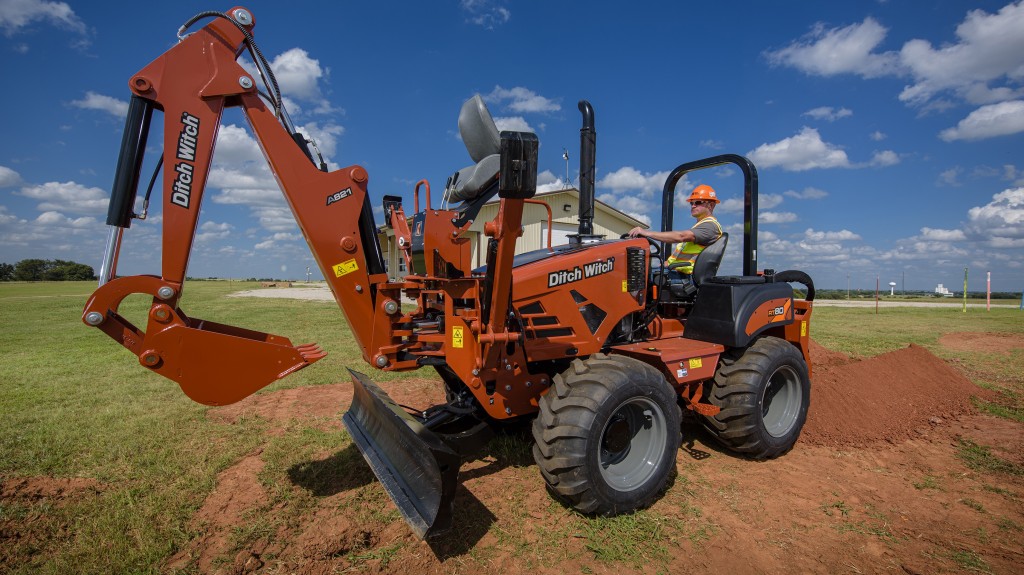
top-left (0, 0), bottom-right (1024, 291)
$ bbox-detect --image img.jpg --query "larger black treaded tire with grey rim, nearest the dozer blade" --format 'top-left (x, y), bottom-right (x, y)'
top-left (534, 354), bottom-right (681, 516)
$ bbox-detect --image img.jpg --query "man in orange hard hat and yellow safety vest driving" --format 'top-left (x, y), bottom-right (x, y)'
top-left (629, 184), bottom-right (722, 276)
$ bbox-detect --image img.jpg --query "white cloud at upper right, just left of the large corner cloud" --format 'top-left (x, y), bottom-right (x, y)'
top-left (766, 17), bottom-right (898, 78)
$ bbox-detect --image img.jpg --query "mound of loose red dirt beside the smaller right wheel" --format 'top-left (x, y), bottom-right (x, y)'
top-left (800, 345), bottom-right (983, 447)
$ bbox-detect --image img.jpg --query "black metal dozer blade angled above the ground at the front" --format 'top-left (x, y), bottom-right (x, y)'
top-left (342, 369), bottom-right (462, 539)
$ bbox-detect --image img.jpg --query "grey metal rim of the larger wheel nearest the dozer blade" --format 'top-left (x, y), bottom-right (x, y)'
top-left (599, 397), bottom-right (669, 491)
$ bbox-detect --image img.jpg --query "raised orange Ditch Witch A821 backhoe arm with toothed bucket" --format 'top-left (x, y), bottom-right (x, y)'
top-left (83, 8), bottom-right (386, 405)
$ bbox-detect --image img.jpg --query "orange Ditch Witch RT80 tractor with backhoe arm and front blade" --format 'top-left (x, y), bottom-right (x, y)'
top-left (82, 7), bottom-right (814, 537)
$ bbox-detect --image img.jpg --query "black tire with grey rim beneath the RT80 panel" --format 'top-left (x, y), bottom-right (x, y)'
top-left (701, 337), bottom-right (811, 459)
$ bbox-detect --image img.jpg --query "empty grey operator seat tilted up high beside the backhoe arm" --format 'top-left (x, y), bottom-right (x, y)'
top-left (444, 94), bottom-right (502, 203)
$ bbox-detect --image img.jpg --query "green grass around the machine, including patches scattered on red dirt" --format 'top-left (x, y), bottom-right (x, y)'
top-left (0, 281), bottom-right (1024, 574)
